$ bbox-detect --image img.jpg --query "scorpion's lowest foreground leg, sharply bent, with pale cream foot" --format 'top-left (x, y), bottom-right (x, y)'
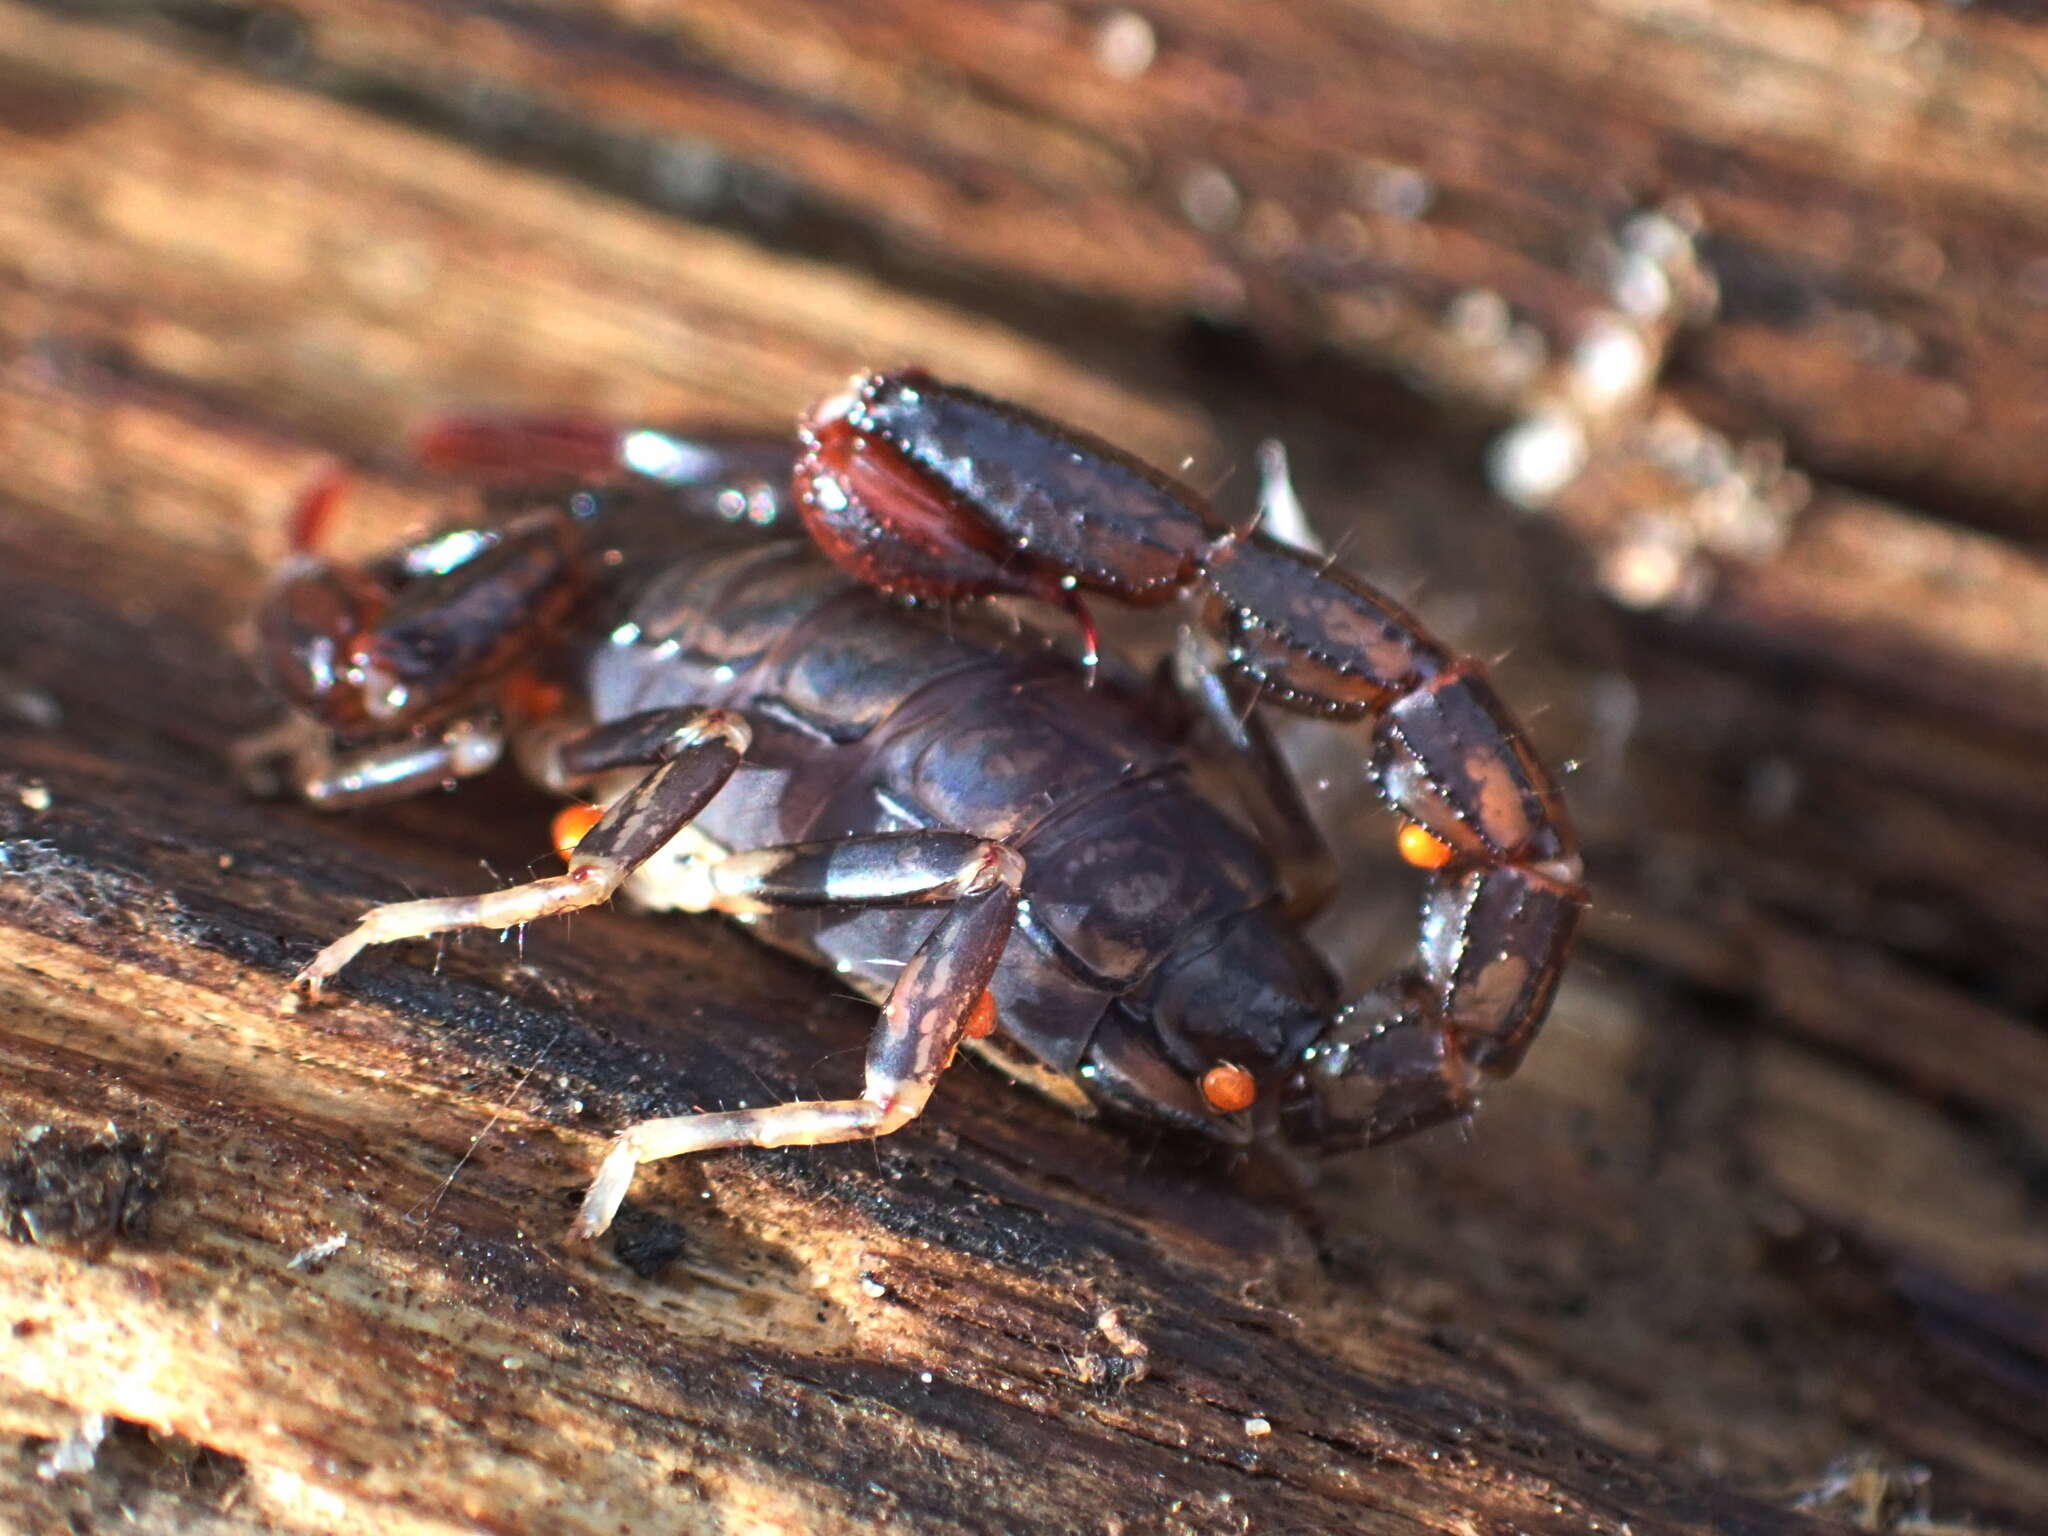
top-left (573, 831), bottom-right (1024, 1237)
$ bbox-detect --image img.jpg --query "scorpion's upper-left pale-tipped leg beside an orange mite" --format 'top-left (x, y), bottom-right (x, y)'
top-left (291, 709), bottom-right (750, 1001)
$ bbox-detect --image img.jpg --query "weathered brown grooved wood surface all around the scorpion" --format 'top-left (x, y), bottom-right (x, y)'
top-left (0, 0), bottom-right (2048, 1532)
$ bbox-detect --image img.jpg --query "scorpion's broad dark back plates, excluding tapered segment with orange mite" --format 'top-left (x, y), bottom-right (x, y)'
top-left (590, 539), bottom-right (1302, 1097)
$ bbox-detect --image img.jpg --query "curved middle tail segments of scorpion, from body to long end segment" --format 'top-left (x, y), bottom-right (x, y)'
top-left (1202, 535), bottom-right (1585, 1147)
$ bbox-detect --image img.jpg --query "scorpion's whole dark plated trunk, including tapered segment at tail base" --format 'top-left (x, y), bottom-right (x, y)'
top-left (586, 541), bottom-right (1335, 1141)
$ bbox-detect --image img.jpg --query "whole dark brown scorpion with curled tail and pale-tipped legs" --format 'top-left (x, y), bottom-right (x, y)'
top-left (239, 371), bottom-right (1585, 1237)
